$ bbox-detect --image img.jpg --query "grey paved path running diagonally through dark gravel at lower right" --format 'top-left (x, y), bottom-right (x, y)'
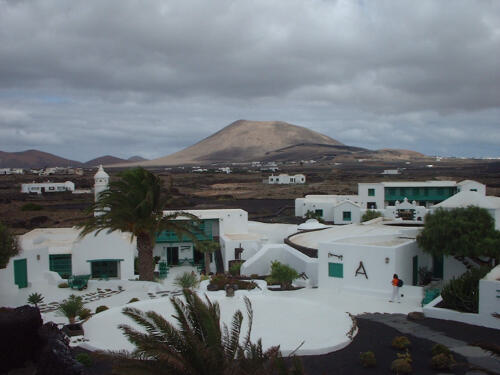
top-left (358, 313), bottom-right (500, 375)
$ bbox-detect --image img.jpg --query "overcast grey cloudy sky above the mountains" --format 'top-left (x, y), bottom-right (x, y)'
top-left (0, 0), bottom-right (500, 161)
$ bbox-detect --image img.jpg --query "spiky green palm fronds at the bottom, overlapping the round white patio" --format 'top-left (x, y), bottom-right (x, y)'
top-left (114, 289), bottom-right (302, 375)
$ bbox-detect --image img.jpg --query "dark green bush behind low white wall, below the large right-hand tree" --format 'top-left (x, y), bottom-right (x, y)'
top-left (441, 267), bottom-right (490, 313)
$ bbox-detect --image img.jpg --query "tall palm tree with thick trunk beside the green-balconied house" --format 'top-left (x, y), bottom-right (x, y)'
top-left (80, 167), bottom-right (198, 281)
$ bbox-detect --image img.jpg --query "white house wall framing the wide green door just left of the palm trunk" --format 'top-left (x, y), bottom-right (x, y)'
top-left (71, 232), bottom-right (137, 280)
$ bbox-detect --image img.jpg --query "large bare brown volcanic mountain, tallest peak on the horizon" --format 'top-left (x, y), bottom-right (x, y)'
top-left (129, 120), bottom-right (349, 166)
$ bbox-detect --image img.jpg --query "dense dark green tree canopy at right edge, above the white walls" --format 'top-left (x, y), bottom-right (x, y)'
top-left (417, 206), bottom-right (500, 263)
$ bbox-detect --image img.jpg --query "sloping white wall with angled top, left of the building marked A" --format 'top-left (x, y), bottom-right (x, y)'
top-left (241, 244), bottom-right (318, 286)
